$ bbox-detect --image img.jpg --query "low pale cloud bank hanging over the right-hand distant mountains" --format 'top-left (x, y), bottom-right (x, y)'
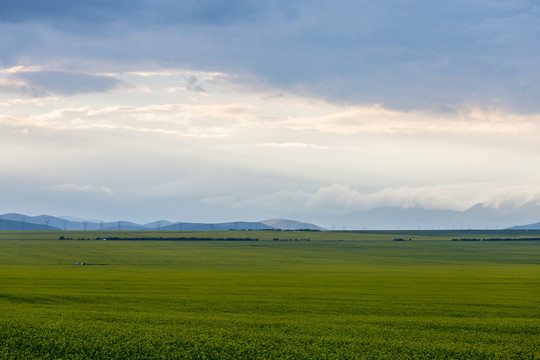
top-left (228, 182), bottom-right (540, 214)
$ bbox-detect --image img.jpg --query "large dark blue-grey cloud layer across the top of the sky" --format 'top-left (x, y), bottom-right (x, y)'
top-left (0, 0), bottom-right (540, 112)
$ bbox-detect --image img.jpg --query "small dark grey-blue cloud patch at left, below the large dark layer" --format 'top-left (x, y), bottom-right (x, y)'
top-left (0, 71), bottom-right (121, 97)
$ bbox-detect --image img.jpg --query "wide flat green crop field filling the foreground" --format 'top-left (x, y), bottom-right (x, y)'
top-left (0, 231), bottom-right (540, 360)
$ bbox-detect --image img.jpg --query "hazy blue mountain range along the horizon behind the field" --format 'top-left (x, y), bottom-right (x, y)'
top-left (0, 202), bottom-right (540, 231)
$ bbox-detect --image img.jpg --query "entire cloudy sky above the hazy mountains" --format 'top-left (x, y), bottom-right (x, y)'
top-left (0, 0), bottom-right (540, 222)
